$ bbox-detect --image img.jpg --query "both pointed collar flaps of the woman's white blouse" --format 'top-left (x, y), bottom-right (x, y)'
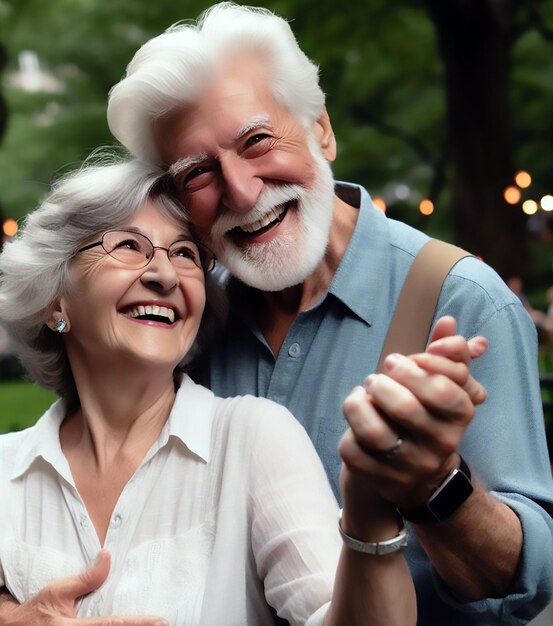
top-left (10, 375), bottom-right (215, 484)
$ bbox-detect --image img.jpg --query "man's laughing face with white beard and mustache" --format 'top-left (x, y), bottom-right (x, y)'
top-left (154, 58), bottom-right (334, 291)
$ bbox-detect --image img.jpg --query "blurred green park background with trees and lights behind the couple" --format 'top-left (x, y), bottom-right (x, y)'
top-left (0, 0), bottom-right (553, 448)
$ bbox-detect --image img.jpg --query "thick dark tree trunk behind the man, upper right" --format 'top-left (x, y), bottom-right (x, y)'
top-left (427, 0), bottom-right (528, 277)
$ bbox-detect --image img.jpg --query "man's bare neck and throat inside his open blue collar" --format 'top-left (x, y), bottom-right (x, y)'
top-left (257, 196), bottom-right (359, 355)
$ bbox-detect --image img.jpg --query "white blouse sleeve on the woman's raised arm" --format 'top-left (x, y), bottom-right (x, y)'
top-left (245, 403), bottom-right (341, 626)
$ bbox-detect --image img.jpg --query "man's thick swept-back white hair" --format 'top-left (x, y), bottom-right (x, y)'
top-left (108, 2), bottom-right (324, 164)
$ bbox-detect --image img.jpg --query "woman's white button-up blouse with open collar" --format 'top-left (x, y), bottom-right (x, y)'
top-left (0, 376), bottom-right (341, 626)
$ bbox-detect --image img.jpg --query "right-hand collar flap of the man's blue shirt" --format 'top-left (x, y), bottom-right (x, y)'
top-left (328, 182), bottom-right (390, 325)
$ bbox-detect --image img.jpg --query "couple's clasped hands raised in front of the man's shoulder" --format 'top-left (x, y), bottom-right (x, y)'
top-left (340, 317), bottom-right (487, 509)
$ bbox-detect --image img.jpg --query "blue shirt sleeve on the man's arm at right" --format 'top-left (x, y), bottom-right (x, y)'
top-left (436, 260), bottom-right (553, 626)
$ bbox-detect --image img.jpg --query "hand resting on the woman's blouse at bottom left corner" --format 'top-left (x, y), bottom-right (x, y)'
top-left (0, 550), bottom-right (169, 626)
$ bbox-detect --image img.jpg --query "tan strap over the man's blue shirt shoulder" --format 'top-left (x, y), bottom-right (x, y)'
top-left (376, 239), bottom-right (471, 372)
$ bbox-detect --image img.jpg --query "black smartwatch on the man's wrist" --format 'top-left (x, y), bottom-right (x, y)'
top-left (398, 455), bottom-right (474, 524)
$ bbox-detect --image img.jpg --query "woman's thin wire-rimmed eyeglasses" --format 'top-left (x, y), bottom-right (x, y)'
top-left (77, 230), bottom-right (215, 272)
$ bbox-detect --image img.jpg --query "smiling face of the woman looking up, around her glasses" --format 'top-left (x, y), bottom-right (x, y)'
top-left (62, 200), bottom-right (205, 373)
